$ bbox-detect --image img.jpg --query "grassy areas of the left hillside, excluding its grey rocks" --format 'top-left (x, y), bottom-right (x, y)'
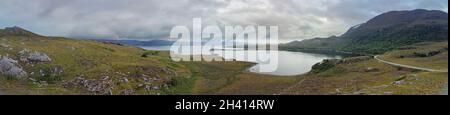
top-left (0, 36), bottom-right (188, 94)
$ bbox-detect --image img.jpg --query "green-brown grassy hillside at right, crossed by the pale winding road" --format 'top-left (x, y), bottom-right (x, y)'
top-left (280, 42), bottom-right (448, 95)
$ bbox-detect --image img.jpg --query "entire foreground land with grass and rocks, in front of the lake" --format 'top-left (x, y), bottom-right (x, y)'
top-left (0, 27), bottom-right (448, 95)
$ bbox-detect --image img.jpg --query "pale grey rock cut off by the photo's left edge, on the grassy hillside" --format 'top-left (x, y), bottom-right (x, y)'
top-left (0, 56), bottom-right (27, 78)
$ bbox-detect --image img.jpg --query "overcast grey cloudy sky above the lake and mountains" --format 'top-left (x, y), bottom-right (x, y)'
top-left (0, 0), bottom-right (448, 40)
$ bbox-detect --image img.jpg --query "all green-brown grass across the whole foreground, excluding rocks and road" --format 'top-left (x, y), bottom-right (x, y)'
top-left (0, 37), bottom-right (448, 95)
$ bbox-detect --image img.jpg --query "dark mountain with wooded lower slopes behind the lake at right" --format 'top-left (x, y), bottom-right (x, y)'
top-left (280, 9), bottom-right (448, 54)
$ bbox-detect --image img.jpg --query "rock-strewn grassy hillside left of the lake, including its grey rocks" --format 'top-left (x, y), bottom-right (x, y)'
top-left (0, 27), bottom-right (189, 94)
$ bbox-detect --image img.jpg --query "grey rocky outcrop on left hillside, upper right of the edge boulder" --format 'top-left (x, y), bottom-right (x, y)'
top-left (19, 49), bottom-right (52, 63)
